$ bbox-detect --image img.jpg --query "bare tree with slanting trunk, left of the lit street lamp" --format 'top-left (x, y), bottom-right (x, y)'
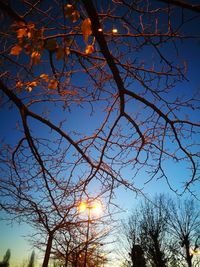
top-left (1, 149), bottom-right (85, 266)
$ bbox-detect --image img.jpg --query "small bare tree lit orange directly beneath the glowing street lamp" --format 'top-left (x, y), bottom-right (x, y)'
top-left (47, 205), bottom-right (113, 267)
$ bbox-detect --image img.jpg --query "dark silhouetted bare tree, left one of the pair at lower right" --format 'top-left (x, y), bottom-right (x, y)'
top-left (119, 195), bottom-right (170, 267)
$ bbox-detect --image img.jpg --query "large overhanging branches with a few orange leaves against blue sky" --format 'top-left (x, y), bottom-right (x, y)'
top-left (1, 1), bottom-right (199, 198)
